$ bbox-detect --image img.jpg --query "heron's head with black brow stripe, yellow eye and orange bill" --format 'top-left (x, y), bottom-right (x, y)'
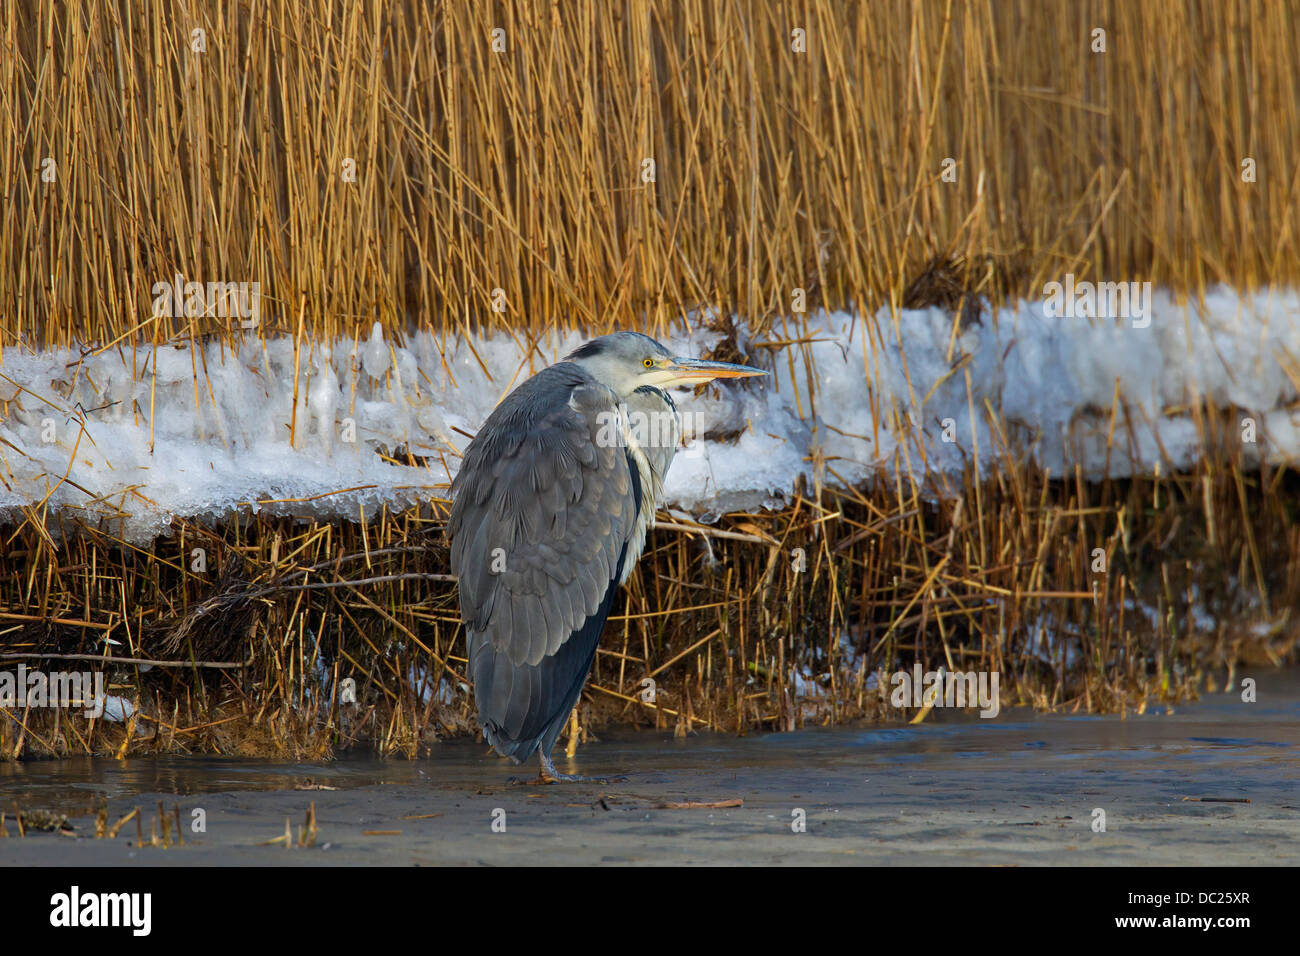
top-left (567, 332), bottom-right (767, 397)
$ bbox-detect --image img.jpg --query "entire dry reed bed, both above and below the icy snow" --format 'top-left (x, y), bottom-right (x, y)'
top-left (0, 0), bottom-right (1300, 757)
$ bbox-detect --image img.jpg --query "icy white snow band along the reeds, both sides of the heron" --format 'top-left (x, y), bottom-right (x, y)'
top-left (0, 289), bottom-right (1300, 544)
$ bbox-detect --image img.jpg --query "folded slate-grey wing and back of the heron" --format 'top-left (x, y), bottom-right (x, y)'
top-left (449, 367), bottom-right (640, 739)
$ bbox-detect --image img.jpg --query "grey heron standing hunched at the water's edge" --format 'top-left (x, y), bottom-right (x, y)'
top-left (447, 332), bottom-right (767, 783)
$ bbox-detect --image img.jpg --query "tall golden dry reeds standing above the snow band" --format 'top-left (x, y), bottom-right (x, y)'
top-left (0, 0), bottom-right (1300, 347)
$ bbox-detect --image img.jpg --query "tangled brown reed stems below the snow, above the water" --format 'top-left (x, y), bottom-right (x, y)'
top-left (0, 434), bottom-right (1300, 758)
